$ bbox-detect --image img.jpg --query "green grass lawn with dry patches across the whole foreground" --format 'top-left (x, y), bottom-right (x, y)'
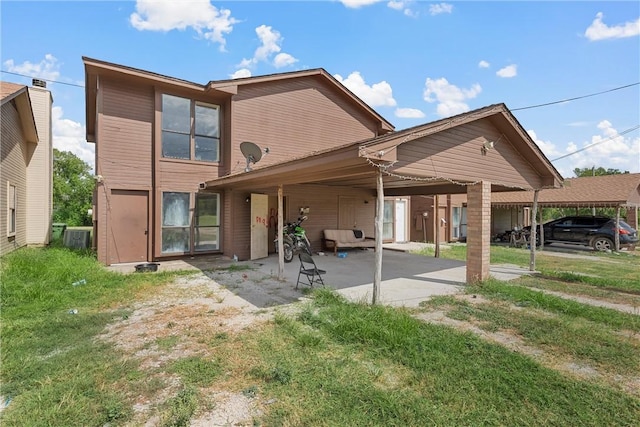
top-left (0, 247), bottom-right (640, 426)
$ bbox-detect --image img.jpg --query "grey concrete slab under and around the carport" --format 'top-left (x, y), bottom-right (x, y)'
top-left (109, 244), bottom-right (530, 308)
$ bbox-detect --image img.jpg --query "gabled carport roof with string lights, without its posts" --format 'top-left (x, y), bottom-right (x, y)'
top-left (205, 104), bottom-right (562, 196)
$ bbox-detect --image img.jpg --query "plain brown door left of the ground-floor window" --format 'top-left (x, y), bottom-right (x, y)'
top-left (108, 190), bottom-right (149, 264)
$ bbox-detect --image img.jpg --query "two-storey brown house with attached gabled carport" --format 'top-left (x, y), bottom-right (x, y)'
top-left (83, 57), bottom-right (562, 284)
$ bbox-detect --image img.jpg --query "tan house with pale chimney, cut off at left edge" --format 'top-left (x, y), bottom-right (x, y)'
top-left (0, 80), bottom-right (53, 255)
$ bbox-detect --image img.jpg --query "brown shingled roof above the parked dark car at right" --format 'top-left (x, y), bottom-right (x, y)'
top-left (491, 173), bottom-right (640, 207)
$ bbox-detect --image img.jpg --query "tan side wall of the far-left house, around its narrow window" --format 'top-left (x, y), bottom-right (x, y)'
top-left (0, 102), bottom-right (29, 255)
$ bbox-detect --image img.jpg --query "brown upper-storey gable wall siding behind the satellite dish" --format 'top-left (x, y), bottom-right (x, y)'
top-left (231, 79), bottom-right (377, 169)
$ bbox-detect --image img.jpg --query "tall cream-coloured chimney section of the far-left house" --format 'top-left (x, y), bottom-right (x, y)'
top-left (27, 87), bottom-right (52, 245)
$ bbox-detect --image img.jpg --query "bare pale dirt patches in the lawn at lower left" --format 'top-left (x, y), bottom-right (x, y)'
top-left (100, 270), bottom-right (304, 427)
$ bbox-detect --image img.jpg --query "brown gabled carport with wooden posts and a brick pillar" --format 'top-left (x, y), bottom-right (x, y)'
top-left (205, 104), bottom-right (562, 303)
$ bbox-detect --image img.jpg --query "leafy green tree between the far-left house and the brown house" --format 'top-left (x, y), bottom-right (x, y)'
top-left (53, 148), bottom-right (95, 226)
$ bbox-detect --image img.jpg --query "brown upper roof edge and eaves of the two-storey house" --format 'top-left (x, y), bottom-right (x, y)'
top-left (82, 56), bottom-right (394, 142)
